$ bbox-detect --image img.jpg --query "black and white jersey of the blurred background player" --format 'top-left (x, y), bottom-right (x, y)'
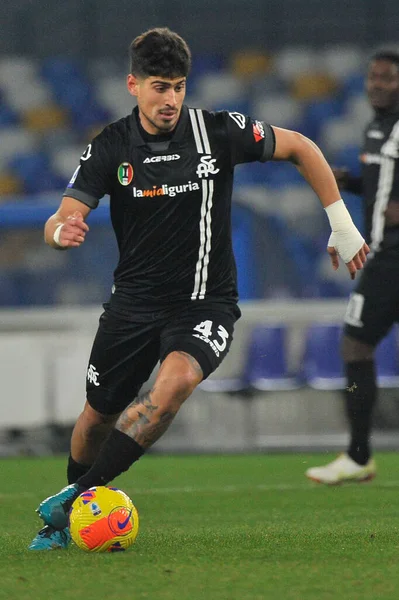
top-left (360, 113), bottom-right (399, 252)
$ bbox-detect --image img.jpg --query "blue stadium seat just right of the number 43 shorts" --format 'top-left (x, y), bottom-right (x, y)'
top-left (246, 324), bottom-right (299, 391)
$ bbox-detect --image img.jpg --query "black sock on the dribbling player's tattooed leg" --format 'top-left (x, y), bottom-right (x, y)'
top-left (75, 429), bottom-right (145, 490)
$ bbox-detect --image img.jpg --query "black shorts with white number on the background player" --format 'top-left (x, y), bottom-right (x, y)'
top-left (344, 250), bottom-right (399, 346)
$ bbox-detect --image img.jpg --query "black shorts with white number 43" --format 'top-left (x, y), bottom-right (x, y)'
top-left (86, 300), bottom-right (241, 414)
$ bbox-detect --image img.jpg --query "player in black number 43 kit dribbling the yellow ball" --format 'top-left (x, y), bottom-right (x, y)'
top-left (30, 28), bottom-right (369, 550)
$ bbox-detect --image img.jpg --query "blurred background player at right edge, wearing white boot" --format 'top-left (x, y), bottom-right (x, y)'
top-left (306, 50), bottom-right (399, 484)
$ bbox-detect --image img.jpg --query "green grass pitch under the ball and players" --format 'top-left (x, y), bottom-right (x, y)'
top-left (0, 453), bottom-right (399, 600)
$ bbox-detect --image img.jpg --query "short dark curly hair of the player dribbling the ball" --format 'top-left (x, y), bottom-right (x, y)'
top-left (129, 27), bottom-right (191, 79)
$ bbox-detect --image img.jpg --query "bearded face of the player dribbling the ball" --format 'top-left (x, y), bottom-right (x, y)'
top-left (127, 75), bottom-right (186, 135)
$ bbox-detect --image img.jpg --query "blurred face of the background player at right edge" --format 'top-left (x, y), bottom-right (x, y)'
top-left (366, 60), bottom-right (399, 110)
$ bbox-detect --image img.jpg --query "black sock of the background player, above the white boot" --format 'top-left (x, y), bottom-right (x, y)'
top-left (345, 360), bottom-right (377, 465)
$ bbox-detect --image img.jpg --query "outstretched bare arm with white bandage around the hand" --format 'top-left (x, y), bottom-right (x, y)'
top-left (272, 127), bottom-right (370, 279)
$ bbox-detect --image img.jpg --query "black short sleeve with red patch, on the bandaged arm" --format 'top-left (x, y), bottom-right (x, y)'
top-left (224, 111), bottom-right (276, 167)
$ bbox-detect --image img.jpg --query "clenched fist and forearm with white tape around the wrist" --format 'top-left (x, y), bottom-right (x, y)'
top-left (44, 196), bottom-right (90, 250)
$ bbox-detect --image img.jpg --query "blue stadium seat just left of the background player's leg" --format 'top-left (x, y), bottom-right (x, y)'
top-left (301, 323), bottom-right (346, 390)
